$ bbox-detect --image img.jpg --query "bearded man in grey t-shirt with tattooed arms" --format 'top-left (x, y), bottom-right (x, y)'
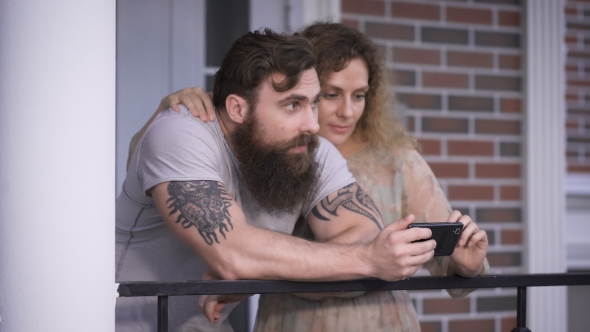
top-left (116, 30), bottom-right (435, 331)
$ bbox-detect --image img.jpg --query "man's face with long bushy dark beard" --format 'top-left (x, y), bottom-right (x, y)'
top-left (232, 70), bottom-right (319, 211)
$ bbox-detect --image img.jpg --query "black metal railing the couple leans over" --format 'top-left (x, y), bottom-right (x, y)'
top-left (117, 273), bottom-right (590, 332)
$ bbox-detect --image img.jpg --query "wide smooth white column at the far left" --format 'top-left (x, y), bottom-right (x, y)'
top-left (0, 0), bottom-right (116, 332)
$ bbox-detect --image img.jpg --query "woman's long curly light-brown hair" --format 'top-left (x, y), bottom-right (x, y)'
top-left (300, 22), bottom-right (418, 149)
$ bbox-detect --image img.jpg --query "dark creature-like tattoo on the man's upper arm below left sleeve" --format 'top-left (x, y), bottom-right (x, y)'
top-left (166, 181), bottom-right (234, 245)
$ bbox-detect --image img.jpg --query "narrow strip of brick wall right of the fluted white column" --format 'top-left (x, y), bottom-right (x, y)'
top-left (565, 0), bottom-right (590, 175)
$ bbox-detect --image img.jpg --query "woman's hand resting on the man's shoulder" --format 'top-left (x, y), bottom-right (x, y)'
top-left (163, 87), bottom-right (215, 122)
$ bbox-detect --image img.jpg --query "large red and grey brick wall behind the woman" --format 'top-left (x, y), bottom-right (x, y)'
top-left (342, 0), bottom-right (528, 332)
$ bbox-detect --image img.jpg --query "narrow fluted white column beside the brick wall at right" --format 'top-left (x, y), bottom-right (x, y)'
top-left (525, 0), bottom-right (567, 332)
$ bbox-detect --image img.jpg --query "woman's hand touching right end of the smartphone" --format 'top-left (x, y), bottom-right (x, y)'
top-left (447, 210), bottom-right (488, 277)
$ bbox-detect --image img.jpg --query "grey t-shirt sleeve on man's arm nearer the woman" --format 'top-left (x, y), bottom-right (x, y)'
top-left (303, 137), bottom-right (356, 217)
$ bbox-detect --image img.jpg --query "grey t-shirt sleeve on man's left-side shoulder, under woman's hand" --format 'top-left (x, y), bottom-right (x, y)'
top-left (137, 110), bottom-right (223, 193)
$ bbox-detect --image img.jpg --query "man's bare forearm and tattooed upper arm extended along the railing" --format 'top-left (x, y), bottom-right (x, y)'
top-left (151, 181), bottom-right (432, 281)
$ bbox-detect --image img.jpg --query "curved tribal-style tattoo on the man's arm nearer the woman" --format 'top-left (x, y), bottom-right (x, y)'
top-left (311, 183), bottom-right (383, 230)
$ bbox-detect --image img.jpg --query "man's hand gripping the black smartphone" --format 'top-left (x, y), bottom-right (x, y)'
top-left (365, 215), bottom-right (436, 281)
